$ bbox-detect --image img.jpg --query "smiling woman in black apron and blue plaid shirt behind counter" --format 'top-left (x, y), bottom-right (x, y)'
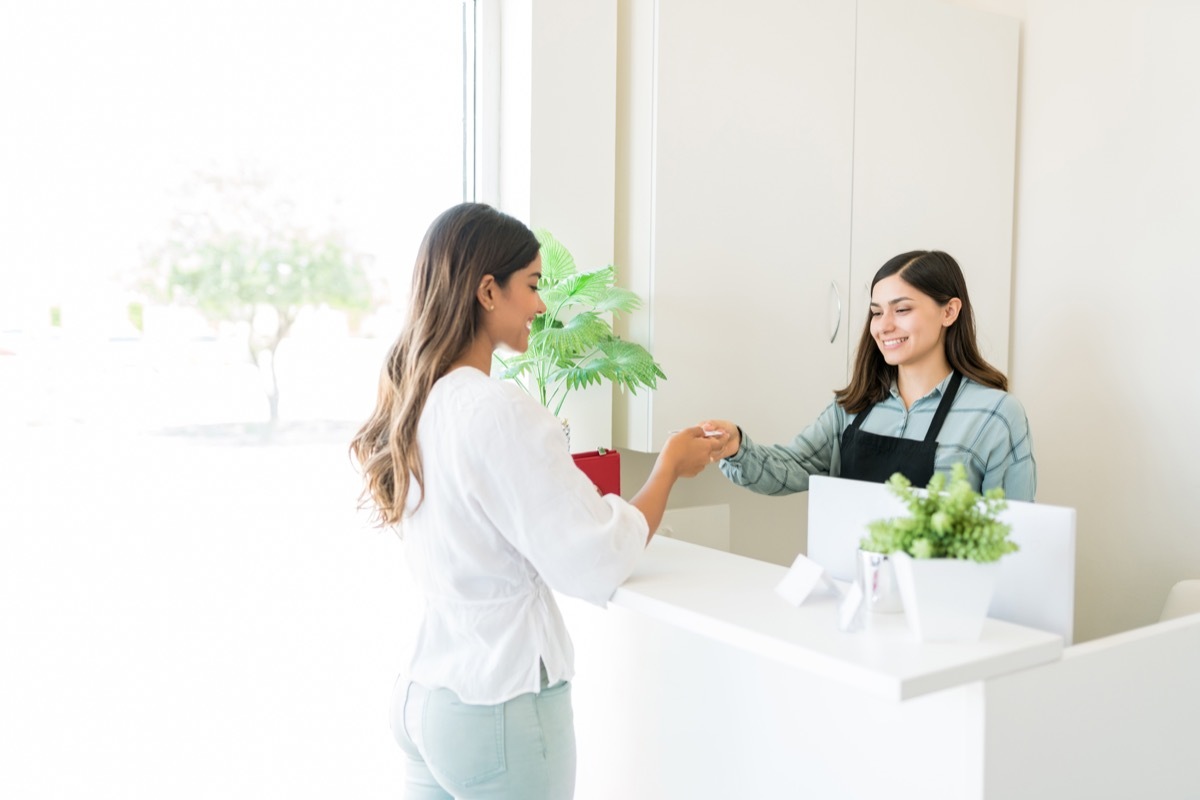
top-left (704, 251), bottom-right (1037, 501)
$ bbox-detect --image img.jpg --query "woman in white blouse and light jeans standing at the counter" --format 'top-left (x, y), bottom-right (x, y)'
top-left (350, 203), bottom-right (718, 800)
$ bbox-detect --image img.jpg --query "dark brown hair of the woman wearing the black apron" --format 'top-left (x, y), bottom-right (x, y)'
top-left (834, 249), bottom-right (1008, 414)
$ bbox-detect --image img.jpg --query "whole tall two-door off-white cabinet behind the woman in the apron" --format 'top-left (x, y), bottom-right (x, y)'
top-left (613, 0), bottom-right (1016, 451)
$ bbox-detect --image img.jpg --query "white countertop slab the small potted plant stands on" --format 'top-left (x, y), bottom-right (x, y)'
top-left (612, 536), bottom-right (1063, 700)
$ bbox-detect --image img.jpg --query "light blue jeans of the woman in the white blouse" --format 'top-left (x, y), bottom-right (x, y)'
top-left (391, 672), bottom-right (575, 800)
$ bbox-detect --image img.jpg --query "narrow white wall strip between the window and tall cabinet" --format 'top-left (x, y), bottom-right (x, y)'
top-left (498, 0), bottom-right (617, 451)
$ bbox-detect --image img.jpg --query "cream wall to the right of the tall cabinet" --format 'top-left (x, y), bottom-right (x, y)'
top-left (1012, 0), bottom-right (1200, 640)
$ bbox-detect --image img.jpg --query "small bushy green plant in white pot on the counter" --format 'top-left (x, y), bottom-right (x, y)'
top-left (859, 464), bottom-right (1018, 640)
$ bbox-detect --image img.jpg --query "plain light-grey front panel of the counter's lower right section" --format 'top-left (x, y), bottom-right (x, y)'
top-left (985, 615), bottom-right (1200, 800)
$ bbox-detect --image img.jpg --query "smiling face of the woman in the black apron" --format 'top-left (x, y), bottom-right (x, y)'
top-left (871, 275), bottom-right (962, 368)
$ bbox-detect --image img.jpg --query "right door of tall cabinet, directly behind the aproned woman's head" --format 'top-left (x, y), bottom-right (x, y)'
top-left (851, 0), bottom-right (1019, 372)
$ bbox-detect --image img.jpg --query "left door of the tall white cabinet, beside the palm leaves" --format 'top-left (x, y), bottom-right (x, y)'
top-left (614, 0), bottom-right (854, 451)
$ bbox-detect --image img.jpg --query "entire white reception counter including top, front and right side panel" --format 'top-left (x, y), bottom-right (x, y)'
top-left (560, 537), bottom-right (1200, 800)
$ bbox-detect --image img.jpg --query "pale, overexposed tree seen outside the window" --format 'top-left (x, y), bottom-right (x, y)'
top-left (145, 173), bottom-right (372, 423)
